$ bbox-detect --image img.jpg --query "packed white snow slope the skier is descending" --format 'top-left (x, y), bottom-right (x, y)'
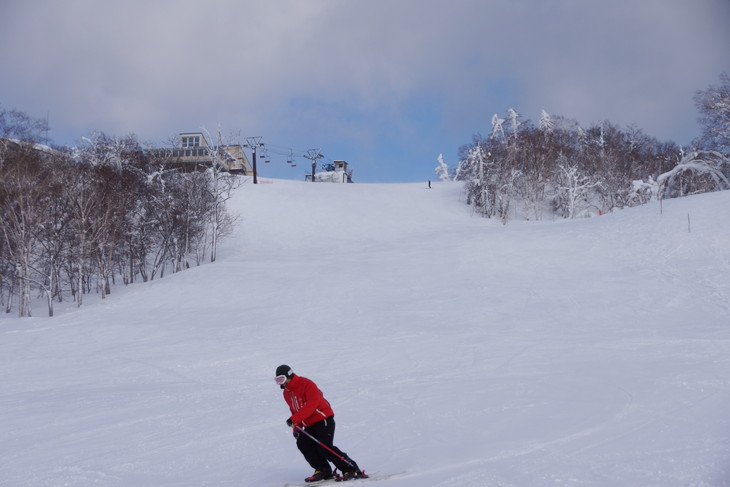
top-left (0, 180), bottom-right (730, 487)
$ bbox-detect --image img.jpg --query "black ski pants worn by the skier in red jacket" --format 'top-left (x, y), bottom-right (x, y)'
top-left (297, 416), bottom-right (358, 473)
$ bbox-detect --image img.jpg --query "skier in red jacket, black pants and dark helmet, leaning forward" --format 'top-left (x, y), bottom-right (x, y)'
top-left (275, 365), bottom-right (367, 482)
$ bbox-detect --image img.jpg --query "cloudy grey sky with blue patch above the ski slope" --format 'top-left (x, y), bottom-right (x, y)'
top-left (0, 0), bottom-right (730, 182)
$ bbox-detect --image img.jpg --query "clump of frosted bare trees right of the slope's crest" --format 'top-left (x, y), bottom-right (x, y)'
top-left (456, 109), bottom-right (681, 220)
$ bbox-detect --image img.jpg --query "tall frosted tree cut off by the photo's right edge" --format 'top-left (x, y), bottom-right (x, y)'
top-left (694, 73), bottom-right (730, 156)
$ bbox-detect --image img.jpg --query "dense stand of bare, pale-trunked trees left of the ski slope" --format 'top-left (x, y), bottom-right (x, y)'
top-left (0, 112), bottom-right (239, 316)
